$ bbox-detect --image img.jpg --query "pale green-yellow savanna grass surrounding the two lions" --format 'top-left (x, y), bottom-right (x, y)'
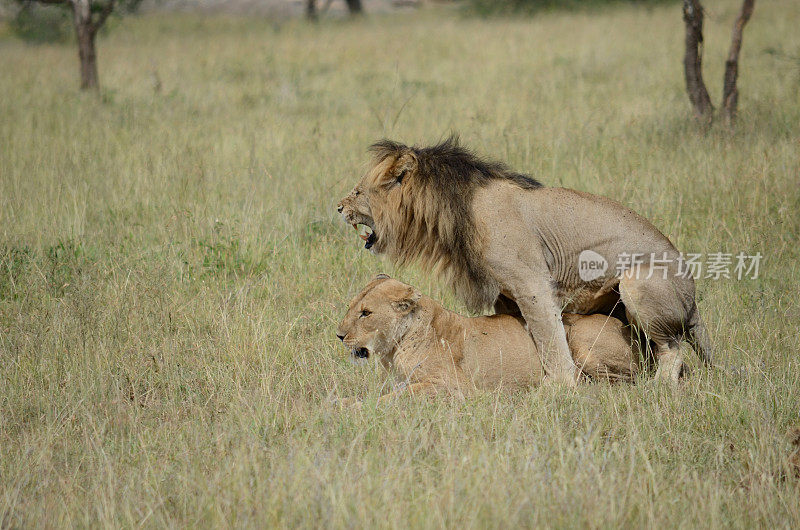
top-left (0, 0), bottom-right (800, 528)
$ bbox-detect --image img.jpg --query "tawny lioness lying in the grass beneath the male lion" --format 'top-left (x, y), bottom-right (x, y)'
top-left (336, 274), bottom-right (639, 401)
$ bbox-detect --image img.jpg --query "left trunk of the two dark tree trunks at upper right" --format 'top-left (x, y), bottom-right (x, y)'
top-left (683, 0), bottom-right (714, 123)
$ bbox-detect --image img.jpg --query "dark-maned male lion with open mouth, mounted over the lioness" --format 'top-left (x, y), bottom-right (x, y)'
top-left (338, 138), bottom-right (711, 385)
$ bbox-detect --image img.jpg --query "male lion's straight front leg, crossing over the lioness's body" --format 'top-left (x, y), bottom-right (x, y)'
top-left (512, 279), bottom-right (580, 386)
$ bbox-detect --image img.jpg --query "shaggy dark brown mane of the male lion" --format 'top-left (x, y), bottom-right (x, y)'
top-left (370, 136), bottom-right (542, 311)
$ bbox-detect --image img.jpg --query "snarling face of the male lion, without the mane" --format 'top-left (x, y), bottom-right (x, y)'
top-left (337, 140), bottom-right (417, 253)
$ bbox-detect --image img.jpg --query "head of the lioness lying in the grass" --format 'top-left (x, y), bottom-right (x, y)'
top-left (336, 274), bottom-right (422, 359)
